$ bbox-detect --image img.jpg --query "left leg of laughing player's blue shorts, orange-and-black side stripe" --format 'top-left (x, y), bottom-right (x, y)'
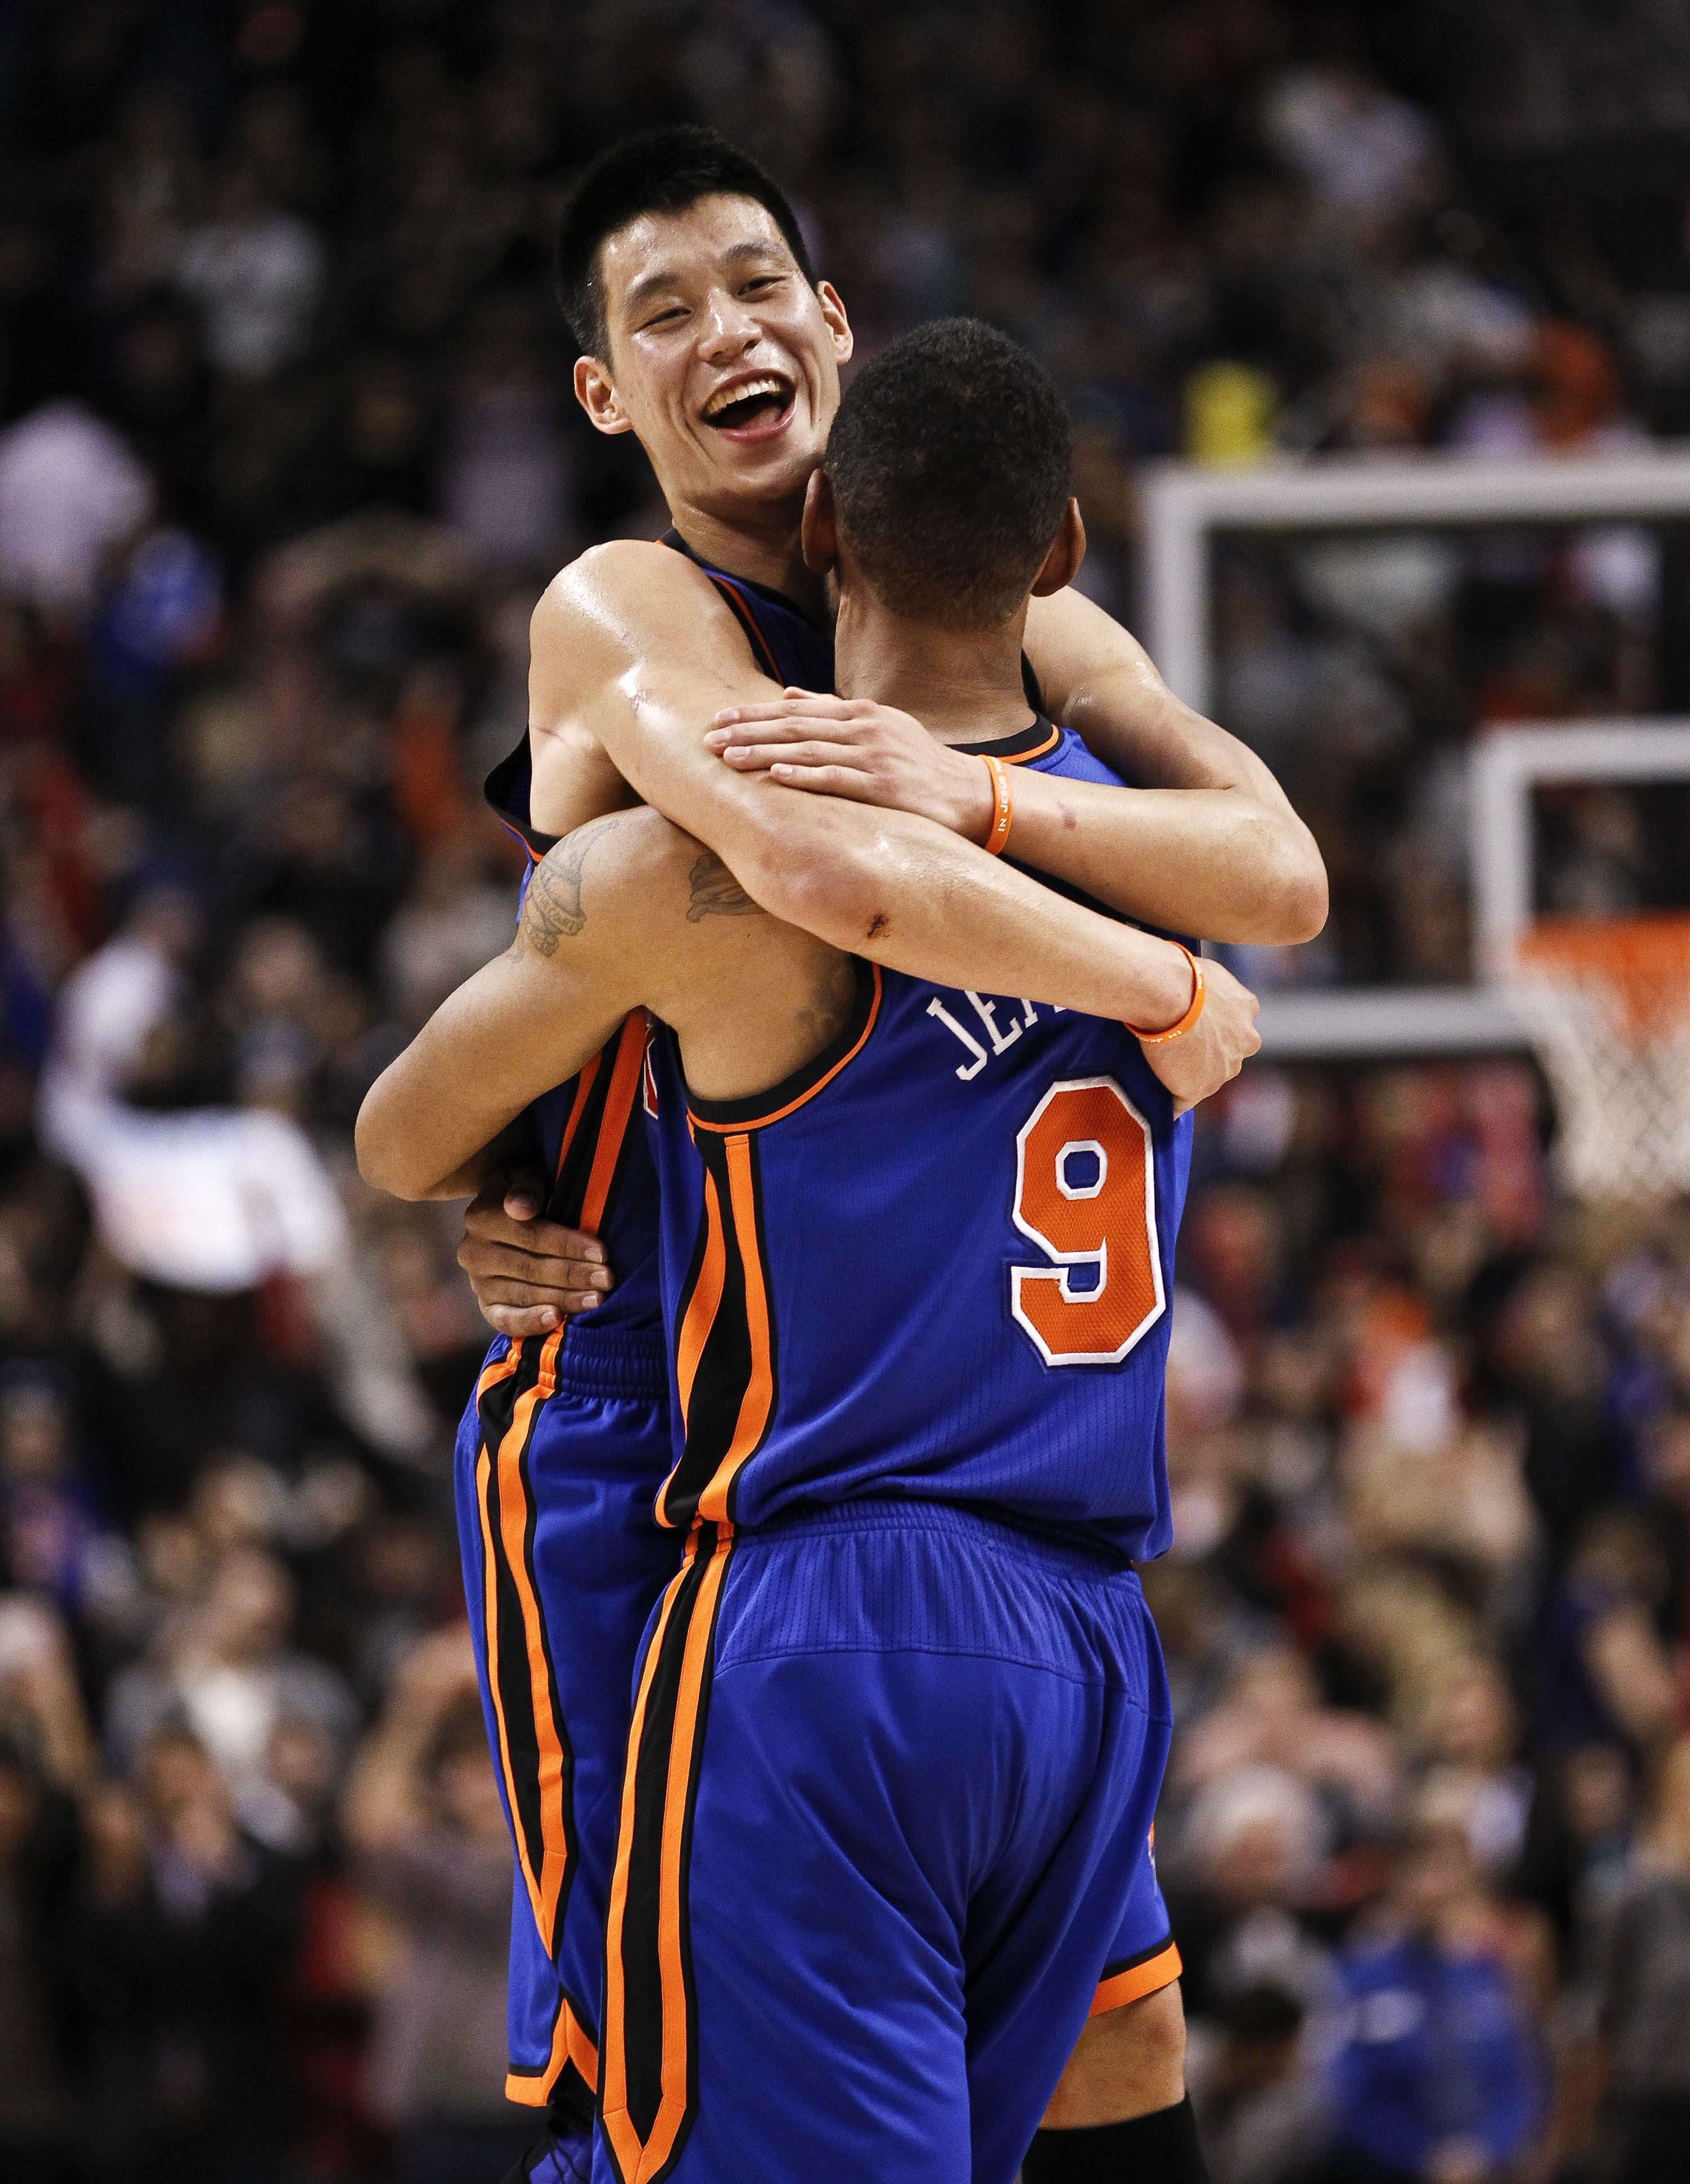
top-left (454, 1321), bottom-right (683, 2107)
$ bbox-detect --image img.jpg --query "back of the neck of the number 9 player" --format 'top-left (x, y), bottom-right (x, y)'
top-left (834, 583), bottom-right (1029, 743)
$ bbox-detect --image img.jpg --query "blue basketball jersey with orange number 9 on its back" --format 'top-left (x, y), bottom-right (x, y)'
top-left (646, 718), bottom-right (1190, 1559)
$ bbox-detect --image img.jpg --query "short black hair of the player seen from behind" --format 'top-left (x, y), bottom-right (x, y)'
top-left (825, 319), bottom-right (1074, 629)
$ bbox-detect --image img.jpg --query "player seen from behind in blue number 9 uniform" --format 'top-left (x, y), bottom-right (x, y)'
top-left (361, 323), bottom-right (1249, 2184)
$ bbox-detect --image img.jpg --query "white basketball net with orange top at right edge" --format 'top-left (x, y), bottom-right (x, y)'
top-left (1511, 911), bottom-right (1690, 1199)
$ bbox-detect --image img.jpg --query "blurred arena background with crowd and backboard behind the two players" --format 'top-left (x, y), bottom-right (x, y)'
top-left (0, 0), bottom-right (1690, 2184)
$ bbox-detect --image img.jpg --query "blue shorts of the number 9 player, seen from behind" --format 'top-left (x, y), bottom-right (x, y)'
top-left (594, 1501), bottom-right (1179, 2184)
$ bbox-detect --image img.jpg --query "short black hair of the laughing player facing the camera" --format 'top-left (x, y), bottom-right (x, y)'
top-left (557, 122), bottom-right (817, 358)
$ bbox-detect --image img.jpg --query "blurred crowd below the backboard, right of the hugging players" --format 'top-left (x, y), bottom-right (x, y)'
top-left (1170, 1062), bottom-right (1690, 2184)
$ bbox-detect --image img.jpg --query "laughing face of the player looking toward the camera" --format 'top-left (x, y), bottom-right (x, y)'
top-left (574, 197), bottom-right (852, 524)
